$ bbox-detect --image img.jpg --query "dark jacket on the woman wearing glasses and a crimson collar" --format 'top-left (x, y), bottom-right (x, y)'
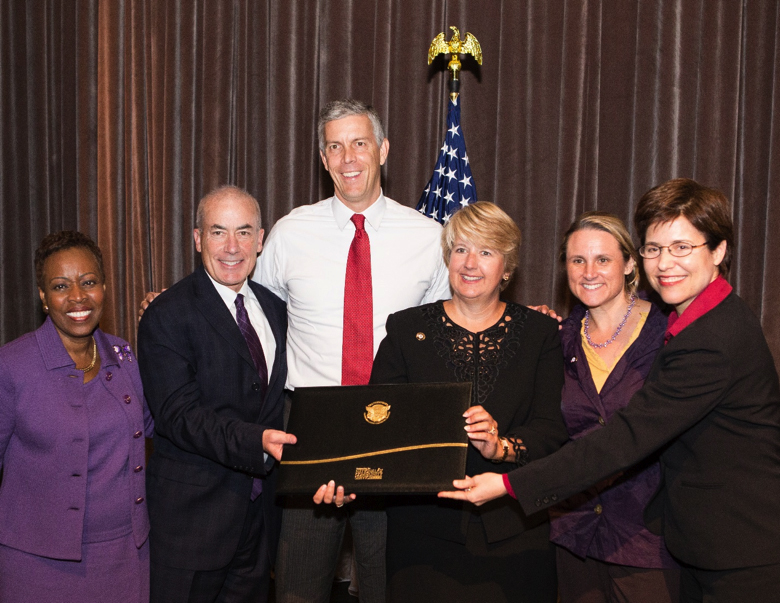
top-left (509, 293), bottom-right (780, 570)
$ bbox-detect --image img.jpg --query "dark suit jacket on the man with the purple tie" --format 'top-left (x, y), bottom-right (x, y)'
top-left (138, 267), bottom-right (287, 570)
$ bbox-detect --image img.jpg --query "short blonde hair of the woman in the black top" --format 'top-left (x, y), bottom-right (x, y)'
top-left (441, 201), bottom-right (521, 291)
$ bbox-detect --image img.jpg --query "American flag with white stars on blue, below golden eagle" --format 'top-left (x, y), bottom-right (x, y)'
top-left (417, 97), bottom-right (477, 224)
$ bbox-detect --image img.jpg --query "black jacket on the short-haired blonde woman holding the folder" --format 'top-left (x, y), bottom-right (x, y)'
top-left (371, 302), bottom-right (568, 543)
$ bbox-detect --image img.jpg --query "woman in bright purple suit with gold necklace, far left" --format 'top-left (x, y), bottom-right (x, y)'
top-left (0, 231), bottom-right (152, 603)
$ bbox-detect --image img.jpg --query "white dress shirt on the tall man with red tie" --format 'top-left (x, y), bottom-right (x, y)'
top-left (253, 194), bottom-right (450, 389)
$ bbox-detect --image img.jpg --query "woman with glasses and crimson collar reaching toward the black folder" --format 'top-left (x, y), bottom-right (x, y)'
top-left (440, 179), bottom-right (780, 603)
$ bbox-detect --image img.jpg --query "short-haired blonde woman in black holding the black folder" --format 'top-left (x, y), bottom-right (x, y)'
top-left (371, 202), bottom-right (567, 603)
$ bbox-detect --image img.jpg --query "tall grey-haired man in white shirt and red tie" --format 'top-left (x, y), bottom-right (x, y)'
top-left (254, 100), bottom-right (450, 603)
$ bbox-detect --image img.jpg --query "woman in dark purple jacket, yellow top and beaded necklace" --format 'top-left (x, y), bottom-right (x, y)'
top-left (550, 211), bottom-right (680, 603)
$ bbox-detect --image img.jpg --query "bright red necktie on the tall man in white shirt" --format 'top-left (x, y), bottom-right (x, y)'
top-left (341, 214), bottom-right (374, 385)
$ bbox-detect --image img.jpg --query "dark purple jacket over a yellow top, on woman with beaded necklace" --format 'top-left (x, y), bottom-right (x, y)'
top-left (550, 305), bottom-right (677, 568)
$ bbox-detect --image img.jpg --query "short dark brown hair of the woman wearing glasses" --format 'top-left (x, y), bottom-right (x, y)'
top-left (634, 178), bottom-right (734, 277)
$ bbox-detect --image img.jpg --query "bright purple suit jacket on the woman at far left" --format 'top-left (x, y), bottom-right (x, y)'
top-left (0, 318), bottom-right (153, 561)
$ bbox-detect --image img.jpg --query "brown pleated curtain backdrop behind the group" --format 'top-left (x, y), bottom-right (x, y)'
top-left (0, 0), bottom-right (780, 370)
